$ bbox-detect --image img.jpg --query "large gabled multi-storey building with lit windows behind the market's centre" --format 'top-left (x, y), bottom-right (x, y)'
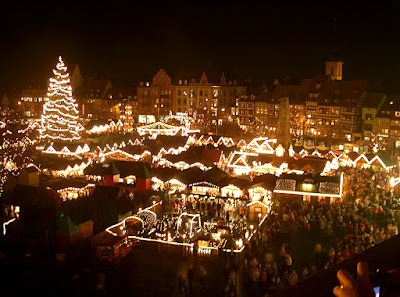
top-left (137, 69), bottom-right (246, 122)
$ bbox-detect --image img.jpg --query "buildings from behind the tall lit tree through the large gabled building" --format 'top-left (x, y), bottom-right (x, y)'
top-left (18, 65), bottom-right (246, 123)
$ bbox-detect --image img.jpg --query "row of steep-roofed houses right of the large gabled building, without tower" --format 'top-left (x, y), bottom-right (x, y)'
top-left (237, 75), bottom-right (400, 148)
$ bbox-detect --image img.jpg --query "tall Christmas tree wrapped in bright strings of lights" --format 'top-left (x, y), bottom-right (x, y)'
top-left (40, 56), bottom-right (83, 141)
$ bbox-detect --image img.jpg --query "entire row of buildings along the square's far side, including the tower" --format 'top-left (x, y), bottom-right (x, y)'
top-left (19, 61), bottom-right (400, 147)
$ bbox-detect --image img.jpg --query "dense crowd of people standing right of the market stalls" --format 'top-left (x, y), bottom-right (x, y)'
top-left (238, 168), bottom-right (400, 292)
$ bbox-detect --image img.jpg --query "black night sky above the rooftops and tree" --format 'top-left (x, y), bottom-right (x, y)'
top-left (0, 0), bottom-right (400, 90)
